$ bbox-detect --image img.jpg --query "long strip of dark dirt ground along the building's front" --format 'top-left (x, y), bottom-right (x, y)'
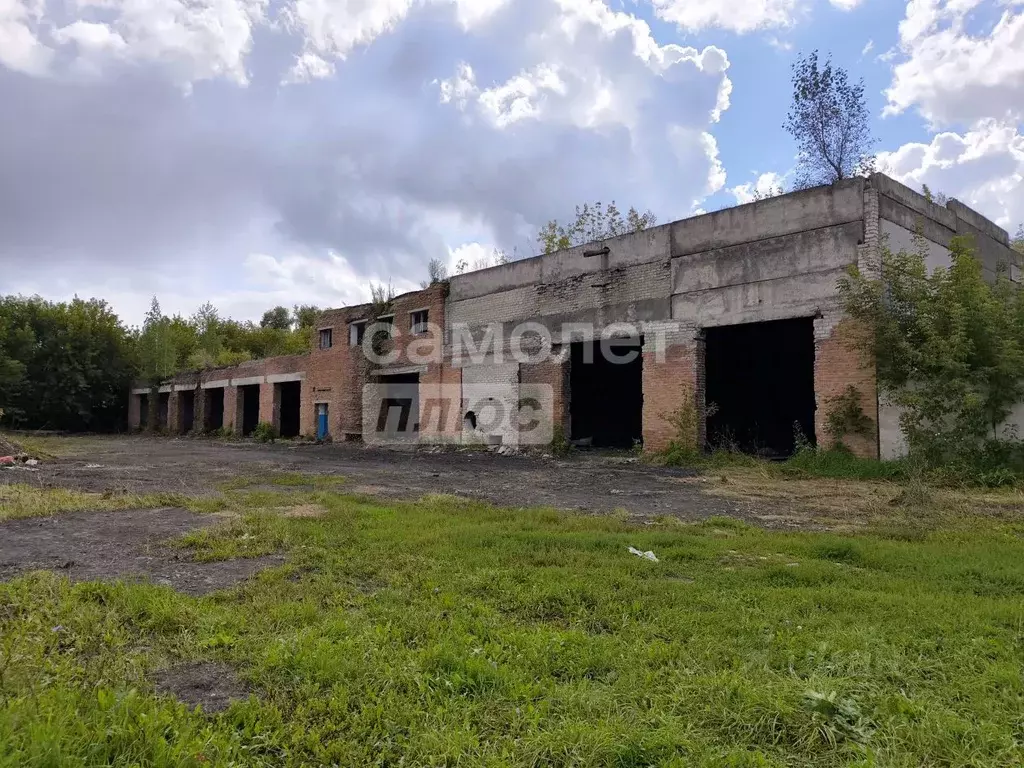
top-left (6, 437), bottom-right (770, 519)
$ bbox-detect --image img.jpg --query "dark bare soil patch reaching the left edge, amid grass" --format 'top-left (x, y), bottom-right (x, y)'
top-left (0, 507), bottom-right (284, 595)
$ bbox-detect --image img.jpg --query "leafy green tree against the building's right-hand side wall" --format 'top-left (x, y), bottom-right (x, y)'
top-left (840, 231), bottom-right (1024, 473)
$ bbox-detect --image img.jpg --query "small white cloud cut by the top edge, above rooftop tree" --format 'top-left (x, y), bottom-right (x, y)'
top-left (651, 0), bottom-right (802, 33)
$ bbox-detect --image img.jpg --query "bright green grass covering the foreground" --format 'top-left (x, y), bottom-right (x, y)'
top-left (0, 478), bottom-right (1024, 767)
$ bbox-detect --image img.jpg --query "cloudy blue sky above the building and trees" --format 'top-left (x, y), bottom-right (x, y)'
top-left (0, 0), bottom-right (1024, 323)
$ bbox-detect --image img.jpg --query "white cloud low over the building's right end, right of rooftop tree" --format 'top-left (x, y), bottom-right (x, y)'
top-left (879, 119), bottom-right (1024, 233)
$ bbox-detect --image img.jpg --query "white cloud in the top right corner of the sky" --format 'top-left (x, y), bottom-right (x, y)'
top-left (885, 0), bottom-right (1024, 127)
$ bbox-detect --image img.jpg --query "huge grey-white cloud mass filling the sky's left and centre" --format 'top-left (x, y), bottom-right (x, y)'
top-left (6, 0), bottom-right (745, 317)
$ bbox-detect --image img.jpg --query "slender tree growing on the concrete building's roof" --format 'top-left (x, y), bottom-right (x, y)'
top-left (783, 51), bottom-right (874, 189)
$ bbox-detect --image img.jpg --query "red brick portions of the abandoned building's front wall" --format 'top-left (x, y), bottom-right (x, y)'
top-left (129, 285), bottom-right (879, 457)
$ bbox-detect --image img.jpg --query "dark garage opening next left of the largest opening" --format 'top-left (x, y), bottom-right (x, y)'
top-left (569, 338), bottom-right (643, 449)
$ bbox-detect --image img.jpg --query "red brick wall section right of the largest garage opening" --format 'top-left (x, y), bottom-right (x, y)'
top-left (814, 314), bottom-right (879, 459)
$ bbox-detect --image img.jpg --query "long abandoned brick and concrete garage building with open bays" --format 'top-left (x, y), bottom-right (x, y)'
top-left (130, 174), bottom-right (1024, 458)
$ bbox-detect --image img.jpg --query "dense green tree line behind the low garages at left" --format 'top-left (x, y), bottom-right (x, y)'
top-left (0, 296), bottom-right (321, 432)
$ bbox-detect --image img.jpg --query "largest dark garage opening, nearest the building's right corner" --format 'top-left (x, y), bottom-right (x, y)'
top-left (705, 317), bottom-right (814, 459)
